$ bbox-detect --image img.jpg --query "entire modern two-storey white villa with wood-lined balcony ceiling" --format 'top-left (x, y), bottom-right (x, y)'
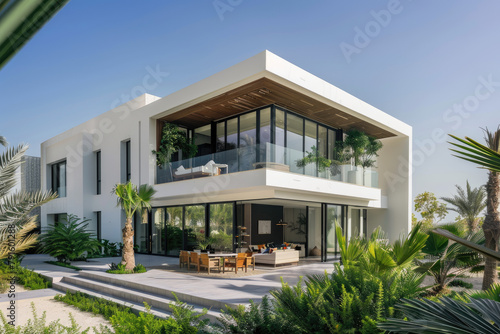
top-left (41, 51), bottom-right (412, 261)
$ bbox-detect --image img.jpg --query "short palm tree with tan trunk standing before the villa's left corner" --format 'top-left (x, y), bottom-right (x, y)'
top-left (113, 181), bottom-right (156, 270)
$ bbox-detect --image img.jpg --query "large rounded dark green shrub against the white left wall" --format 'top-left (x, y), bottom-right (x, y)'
top-left (40, 215), bottom-right (99, 264)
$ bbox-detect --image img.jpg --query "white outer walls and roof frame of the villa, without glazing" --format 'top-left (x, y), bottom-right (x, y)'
top-left (41, 51), bottom-right (412, 253)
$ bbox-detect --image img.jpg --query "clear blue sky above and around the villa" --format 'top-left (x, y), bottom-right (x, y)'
top-left (0, 0), bottom-right (500, 222)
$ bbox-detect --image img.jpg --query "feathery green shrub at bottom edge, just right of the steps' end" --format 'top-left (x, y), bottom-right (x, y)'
top-left (214, 296), bottom-right (286, 334)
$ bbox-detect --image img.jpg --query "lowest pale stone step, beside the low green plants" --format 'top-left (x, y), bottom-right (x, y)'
top-left (53, 276), bottom-right (220, 321)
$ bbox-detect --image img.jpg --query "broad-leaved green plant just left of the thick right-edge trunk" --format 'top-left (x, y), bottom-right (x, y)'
top-left (417, 224), bottom-right (484, 293)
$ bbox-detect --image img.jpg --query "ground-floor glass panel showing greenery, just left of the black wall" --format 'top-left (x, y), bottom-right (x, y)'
top-left (210, 203), bottom-right (233, 251)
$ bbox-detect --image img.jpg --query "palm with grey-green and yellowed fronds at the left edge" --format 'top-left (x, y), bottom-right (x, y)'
top-left (0, 144), bottom-right (56, 259)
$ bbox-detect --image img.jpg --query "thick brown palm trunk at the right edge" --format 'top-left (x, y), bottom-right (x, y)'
top-left (483, 171), bottom-right (500, 290)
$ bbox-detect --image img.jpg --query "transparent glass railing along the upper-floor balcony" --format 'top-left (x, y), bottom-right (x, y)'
top-left (156, 143), bottom-right (378, 188)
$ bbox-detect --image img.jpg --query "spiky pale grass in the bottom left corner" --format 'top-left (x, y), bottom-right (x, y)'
top-left (0, 302), bottom-right (89, 334)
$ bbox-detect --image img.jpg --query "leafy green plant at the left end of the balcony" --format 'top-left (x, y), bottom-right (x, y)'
top-left (151, 122), bottom-right (198, 182)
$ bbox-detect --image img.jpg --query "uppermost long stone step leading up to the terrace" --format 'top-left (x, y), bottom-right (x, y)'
top-left (78, 270), bottom-right (238, 311)
